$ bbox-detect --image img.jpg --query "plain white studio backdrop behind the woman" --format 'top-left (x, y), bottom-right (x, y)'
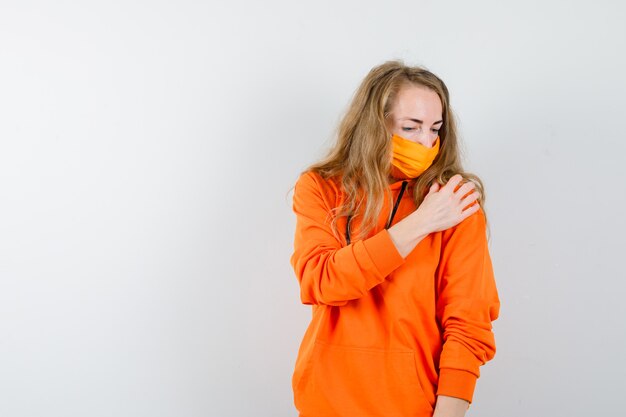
top-left (0, 0), bottom-right (626, 417)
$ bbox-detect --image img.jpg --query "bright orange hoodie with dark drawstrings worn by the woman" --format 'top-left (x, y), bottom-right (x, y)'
top-left (290, 172), bottom-right (500, 417)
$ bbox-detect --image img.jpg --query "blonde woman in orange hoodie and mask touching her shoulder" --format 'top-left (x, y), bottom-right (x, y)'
top-left (290, 61), bottom-right (500, 417)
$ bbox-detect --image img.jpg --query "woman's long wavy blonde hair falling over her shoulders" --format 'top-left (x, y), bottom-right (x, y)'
top-left (292, 60), bottom-right (486, 241)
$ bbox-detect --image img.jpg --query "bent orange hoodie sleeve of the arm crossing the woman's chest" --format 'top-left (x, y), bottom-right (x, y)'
top-left (290, 173), bottom-right (404, 306)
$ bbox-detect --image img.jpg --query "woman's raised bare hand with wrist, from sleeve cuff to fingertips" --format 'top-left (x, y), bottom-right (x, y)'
top-left (388, 174), bottom-right (480, 258)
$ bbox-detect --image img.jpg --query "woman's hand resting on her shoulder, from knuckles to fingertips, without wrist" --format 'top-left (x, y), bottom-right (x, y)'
top-left (415, 174), bottom-right (480, 233)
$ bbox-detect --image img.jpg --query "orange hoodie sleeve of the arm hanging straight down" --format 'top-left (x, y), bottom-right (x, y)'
top-left (437, 208), bottom-right (500, 403)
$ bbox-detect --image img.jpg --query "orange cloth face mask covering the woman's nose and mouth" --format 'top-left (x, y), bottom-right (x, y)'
top-left (391, 134), bottom-right (439, 178)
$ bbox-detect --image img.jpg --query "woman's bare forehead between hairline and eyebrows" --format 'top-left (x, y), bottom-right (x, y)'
top-left (391, 85), bottom-right (443, 120)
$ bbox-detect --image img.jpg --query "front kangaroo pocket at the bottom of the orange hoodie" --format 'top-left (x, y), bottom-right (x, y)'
top-left (297, 341), bottom-right (433, 417)
